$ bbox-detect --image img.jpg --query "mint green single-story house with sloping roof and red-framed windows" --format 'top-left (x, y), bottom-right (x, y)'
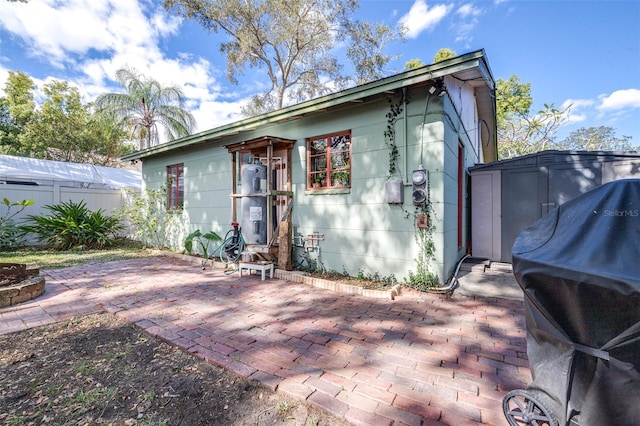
top-left (124, 50), bottom-right (497, 282)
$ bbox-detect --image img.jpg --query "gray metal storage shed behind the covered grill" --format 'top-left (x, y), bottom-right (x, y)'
top-left (469, 151), bottom-right (640, 263)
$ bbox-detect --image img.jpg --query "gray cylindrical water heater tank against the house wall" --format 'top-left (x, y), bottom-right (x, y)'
top-left (240, 163), bottom-right (267, 244)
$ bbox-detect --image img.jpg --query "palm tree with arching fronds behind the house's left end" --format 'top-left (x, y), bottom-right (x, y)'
top-left (95, 67), bottom-right (196, 149)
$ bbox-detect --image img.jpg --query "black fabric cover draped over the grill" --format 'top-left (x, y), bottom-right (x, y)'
top-left (512, 179), bottom-right (640, 426)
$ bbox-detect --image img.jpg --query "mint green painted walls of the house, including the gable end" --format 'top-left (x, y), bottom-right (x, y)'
top-left (135, 53), bottom-right (492, 282)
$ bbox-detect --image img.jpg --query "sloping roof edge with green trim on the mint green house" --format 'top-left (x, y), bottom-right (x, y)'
top-left (122, 50), bottom-right (497, 161)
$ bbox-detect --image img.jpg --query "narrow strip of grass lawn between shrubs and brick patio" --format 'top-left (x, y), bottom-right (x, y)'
top-left (0, 240), bottom-right (153, 269)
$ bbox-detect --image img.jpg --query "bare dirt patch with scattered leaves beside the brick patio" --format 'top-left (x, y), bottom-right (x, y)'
top-left (0, 313), bottom-right (349, 426)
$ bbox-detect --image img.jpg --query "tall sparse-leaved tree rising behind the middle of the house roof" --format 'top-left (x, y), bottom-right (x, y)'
top-left (164, 0), bottom-right (403, 115)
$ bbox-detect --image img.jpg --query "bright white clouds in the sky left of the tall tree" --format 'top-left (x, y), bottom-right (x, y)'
top-left (0, 0), bottom-right (246, 131)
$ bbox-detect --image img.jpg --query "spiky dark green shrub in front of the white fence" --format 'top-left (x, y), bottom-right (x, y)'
top-left (20, 201), bottom-right (123, 250)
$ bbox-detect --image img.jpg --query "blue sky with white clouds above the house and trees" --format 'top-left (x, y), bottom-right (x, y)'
top-left (0, 0), bottom-right (640, 146)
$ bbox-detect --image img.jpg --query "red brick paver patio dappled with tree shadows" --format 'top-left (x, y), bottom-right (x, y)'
top-left (0, 257), bottom-right (531, 425)
